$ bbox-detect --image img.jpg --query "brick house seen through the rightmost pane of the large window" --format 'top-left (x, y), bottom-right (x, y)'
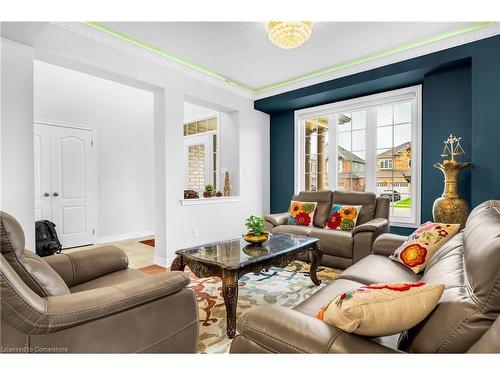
top-left (377, 142), bottom-right (411, 199)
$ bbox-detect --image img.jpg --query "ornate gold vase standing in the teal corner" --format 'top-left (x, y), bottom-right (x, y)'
top-left (432, 160), bottom-right (471, 229)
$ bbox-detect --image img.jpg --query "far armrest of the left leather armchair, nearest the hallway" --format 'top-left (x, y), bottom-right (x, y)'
top-left (43, 245), bottom-right (128, 287)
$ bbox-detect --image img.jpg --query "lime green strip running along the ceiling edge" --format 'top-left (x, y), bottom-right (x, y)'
top-left (85, 21), bottom-right (496, 94)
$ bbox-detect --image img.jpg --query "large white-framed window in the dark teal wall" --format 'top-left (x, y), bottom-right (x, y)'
top-left (295, 86), bottom-right (421, 227)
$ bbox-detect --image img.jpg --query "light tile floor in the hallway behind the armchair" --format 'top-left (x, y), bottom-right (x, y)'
top-left (62, 236), bottom-right (155, 268)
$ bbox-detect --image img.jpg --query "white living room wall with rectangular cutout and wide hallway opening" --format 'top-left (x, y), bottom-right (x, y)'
top-left (2, 23), bottom-right (269, 265)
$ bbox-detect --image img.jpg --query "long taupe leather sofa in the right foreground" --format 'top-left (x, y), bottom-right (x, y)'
top-left (231, 200), bottom-right (500, 353)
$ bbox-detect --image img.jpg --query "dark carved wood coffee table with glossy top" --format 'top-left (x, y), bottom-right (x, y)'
top-left (170, 233), bottom-right (323, 338)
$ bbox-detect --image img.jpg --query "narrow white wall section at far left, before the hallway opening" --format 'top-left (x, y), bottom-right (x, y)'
top-left (0, 39), bottom-right (35, 251)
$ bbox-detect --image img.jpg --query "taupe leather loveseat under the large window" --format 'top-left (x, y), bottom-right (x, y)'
top-left (264, 190), bottom-right (390, 269)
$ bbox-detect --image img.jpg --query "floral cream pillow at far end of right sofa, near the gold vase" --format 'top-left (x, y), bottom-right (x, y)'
top-left (389, 221), bottom-right (460, 273)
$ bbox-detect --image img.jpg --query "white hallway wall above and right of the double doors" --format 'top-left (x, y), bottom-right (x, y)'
top-left (34, 61), bottom-right (154, 242)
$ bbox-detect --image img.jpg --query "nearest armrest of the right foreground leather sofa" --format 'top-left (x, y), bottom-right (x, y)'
top-left (231, 305), bottom-right (396, 353)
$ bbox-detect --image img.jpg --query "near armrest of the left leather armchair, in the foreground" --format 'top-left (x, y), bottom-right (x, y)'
top-left (2, 272), bottom-right (189, 335)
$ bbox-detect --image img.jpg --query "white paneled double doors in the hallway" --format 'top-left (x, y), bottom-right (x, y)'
top-left (35, 124), bottom-right (94, 248)
